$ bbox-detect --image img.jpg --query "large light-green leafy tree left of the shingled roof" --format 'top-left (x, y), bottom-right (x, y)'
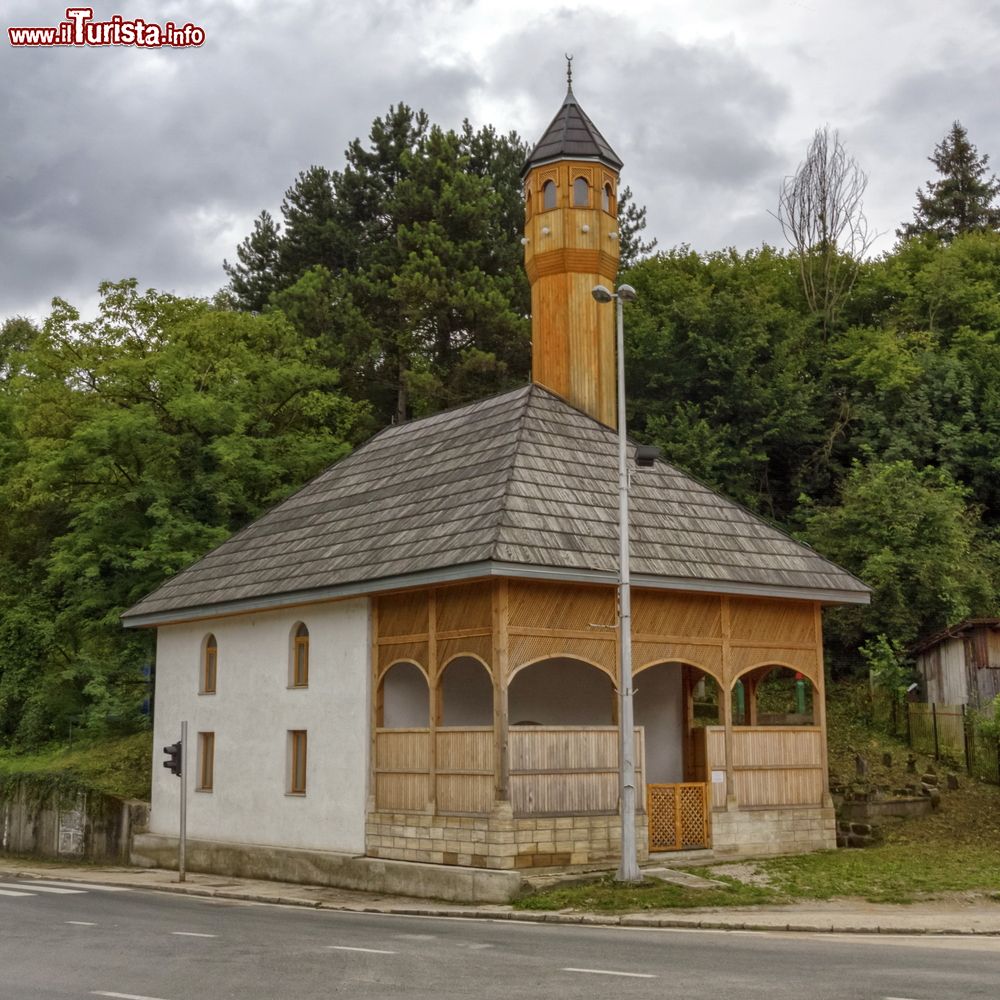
top-left (0, 281), bottom-right (363, 744)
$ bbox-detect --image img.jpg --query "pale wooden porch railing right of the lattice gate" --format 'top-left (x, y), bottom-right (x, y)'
top-left (705, 726), bottom-right (826, 808)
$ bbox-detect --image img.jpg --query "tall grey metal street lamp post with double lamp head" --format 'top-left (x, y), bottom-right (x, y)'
top-left (591, 285), bottom-right (642, 882)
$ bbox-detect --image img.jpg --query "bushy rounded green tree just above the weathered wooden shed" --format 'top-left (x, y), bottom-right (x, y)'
top-left (802, 459), bottom-right (1000, 650)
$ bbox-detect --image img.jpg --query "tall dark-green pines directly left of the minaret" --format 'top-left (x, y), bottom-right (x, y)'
top-left (227, 104), bottom-right (530, 424)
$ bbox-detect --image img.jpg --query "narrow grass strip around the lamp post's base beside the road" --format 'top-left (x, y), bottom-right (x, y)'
top-left (514, 869), bottom-right (781, 913)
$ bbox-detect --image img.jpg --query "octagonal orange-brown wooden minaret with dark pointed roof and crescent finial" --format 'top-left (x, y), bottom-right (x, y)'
top-left (521, 66), bottom-right (622, 427)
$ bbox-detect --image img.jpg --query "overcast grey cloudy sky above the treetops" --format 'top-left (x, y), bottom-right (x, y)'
top-left (0, 0), bottom-right (1000, 319)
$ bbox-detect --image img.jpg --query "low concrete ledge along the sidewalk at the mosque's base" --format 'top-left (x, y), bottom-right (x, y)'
top-left (131, 833), bottom-right (521, 903)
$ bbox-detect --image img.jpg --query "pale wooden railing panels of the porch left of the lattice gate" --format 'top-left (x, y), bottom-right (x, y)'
top-left (375, 726), bottom-right (645, 816)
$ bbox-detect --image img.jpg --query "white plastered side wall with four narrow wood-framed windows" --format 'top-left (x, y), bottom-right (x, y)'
top-left (150, 598), bottom-right (370, 854)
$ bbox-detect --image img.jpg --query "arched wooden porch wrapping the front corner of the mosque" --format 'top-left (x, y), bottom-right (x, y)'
top-left (369, 579), bottom-right (829, 867)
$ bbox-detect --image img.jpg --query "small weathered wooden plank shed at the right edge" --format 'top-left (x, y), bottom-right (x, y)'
top-left (911, 618), bottom-right (1000, 708)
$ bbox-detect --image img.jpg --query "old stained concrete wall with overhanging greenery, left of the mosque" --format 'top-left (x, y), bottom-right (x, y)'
top-left (0, 779), bottom-right (149, 863)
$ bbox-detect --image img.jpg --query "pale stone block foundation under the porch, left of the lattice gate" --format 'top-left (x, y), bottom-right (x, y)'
top-left (366, 812), bottom-right (648, 870)
